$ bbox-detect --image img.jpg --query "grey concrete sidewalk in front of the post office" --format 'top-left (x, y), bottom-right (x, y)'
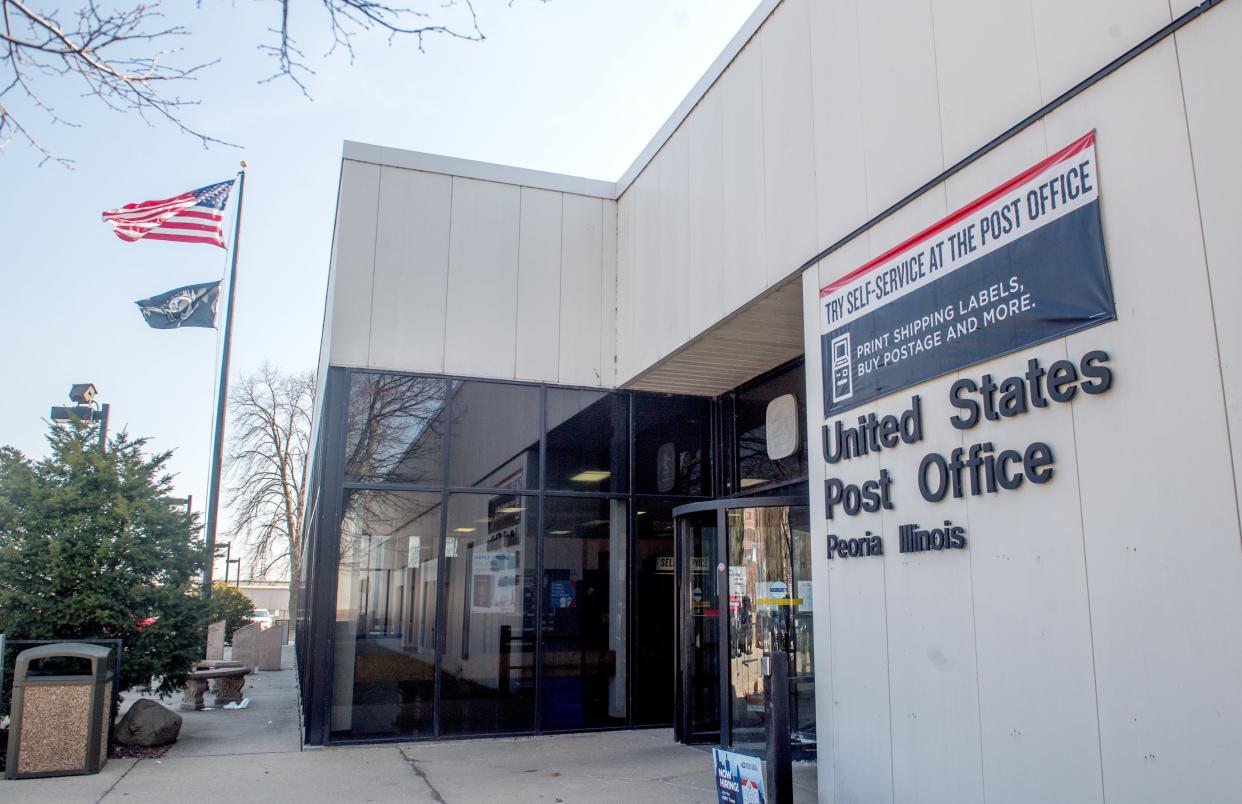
top-left (0, 651), bottom-right (816, 804)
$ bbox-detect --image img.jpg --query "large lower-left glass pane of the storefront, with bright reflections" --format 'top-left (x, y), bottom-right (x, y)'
top-left (332, 490), bottom-right (440, 737)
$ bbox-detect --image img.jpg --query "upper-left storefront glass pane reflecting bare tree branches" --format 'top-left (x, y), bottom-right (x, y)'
top-left (345, 372), bottom-right (446, 485)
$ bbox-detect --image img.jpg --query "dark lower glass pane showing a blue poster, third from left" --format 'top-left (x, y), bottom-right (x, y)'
top-left (540, 497), bottom-right (628, 731)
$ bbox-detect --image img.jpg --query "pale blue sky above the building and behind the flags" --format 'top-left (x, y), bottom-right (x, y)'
top-left (0, 0), bottom-right (756, 574)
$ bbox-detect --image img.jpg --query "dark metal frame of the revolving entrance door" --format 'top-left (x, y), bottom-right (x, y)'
top-left (673, 496), bottom-right (810, 747)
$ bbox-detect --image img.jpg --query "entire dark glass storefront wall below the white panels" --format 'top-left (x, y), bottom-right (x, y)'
top-left (309, 369), bottom-right (814, 741)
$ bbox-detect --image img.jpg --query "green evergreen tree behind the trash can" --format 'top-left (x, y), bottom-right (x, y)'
top-left (0, 423), bottom-right (206, 695)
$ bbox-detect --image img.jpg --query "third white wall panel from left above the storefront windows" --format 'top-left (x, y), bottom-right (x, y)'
top-left (445, 178), bottom-right (520, 378)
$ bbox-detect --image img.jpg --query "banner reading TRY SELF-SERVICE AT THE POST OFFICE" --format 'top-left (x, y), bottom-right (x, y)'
top-left (820, 132), bottom-right (1117, 416)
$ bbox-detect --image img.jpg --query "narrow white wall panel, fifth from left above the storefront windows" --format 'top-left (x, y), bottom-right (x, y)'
top-left (561, 195), bottom-right (604, 385)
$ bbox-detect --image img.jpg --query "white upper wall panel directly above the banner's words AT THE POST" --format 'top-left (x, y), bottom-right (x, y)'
top-left (932, 0), bottom-right (1042, 166)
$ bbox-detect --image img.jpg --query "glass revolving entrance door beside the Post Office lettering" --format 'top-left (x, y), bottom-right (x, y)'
top-left (674, 497), bottom-right (815, 756)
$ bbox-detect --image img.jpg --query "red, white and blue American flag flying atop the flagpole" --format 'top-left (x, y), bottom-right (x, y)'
top-left (103, 179), bottom-right (233, 249)
